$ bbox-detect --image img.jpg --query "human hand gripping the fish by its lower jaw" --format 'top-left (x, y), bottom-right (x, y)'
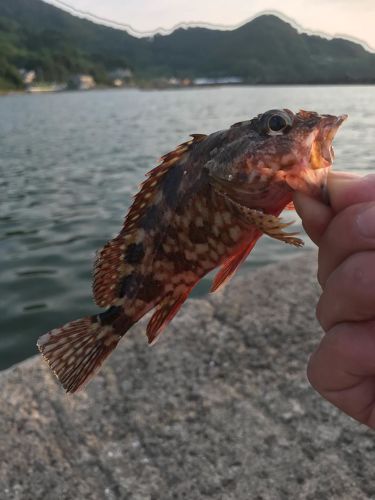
top-left (294, 173), bottom-right (375, 429)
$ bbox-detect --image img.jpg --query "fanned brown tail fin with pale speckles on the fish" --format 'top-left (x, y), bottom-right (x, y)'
top-left (37, 316), bottom-right (121, 393)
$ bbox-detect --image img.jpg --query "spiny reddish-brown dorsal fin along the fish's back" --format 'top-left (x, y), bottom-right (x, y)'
top-left (93, 134), bottom-right (207, 307)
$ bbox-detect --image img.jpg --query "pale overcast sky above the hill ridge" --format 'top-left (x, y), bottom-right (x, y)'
top-left (47, 0), bottom-right (375, 49)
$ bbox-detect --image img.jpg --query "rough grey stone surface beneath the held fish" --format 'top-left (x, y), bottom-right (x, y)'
top-left (0, 252), bottom-right (375, 500)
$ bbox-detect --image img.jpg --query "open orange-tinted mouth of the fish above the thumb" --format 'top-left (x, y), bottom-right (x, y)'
top-left (309, 115), bottom-right (348, 170)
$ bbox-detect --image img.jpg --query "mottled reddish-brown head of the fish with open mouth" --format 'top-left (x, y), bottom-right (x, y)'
top-left (209, 109), bottom-right (347, 207)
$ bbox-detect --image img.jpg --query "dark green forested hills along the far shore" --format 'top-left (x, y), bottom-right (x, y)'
top-left (0, 0), bottom-right (375, 88)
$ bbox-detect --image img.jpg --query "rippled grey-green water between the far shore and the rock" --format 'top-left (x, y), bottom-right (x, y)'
top-left (0, 87), bottom-right (375, 369)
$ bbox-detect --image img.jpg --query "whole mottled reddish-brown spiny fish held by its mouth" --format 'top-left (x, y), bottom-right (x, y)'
top-left (37, 109), bottom-right (347, 393)
